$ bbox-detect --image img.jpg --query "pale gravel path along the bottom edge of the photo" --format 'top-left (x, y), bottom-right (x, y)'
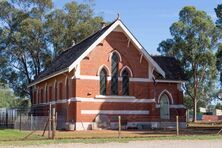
top-left (7, 140), bottom-right (222, 148)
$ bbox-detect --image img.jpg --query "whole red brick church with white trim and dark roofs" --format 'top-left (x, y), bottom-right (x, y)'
top-left (29, 19), bottom-right (186, 130)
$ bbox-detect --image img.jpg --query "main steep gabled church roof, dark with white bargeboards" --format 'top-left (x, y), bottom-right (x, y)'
top-left (29, 19), bottom-right (165, 87)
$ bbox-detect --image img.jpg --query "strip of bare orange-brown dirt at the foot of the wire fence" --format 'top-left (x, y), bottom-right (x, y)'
top-left (39, 128), bottom-right (222, 139)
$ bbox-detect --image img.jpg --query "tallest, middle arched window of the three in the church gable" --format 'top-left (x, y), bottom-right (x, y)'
top-left (111, 52), bottom-right (119, 95)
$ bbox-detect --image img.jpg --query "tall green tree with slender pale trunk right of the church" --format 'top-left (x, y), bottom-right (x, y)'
top-left (157, 6), bottom-right (218, 122)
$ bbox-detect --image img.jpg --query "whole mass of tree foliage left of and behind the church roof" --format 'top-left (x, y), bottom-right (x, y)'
top-left (0, 0), bottom-right (103, 97)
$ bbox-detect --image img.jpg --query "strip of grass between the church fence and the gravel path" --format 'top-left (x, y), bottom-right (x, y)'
top-left (0, 129), bottom-right (222, 147)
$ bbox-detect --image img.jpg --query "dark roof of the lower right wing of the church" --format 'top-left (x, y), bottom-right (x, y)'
top-left (152, 56), bottom-right (188, 81)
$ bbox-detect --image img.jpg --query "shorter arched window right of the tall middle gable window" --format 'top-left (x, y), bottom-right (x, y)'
top-left (122, 68), bottom-right (129, 96)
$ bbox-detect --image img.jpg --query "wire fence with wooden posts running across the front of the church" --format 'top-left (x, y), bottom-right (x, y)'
top-left (0, 108), bottom-right (222, 141)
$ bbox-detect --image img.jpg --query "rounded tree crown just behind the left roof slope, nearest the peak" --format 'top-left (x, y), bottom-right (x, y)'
top-left (46, 1), bottom-right (103, 56)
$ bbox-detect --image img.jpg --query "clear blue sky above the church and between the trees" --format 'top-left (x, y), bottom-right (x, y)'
top-left (54, 0), bottom-right (222, 54)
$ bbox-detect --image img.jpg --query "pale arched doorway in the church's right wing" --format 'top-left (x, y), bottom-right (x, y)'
top-left (160, 94), bottom-right (170, 119)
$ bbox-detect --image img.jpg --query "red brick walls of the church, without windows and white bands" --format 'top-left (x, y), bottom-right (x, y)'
top-left (33, 32), bottom-right (186, 127)
